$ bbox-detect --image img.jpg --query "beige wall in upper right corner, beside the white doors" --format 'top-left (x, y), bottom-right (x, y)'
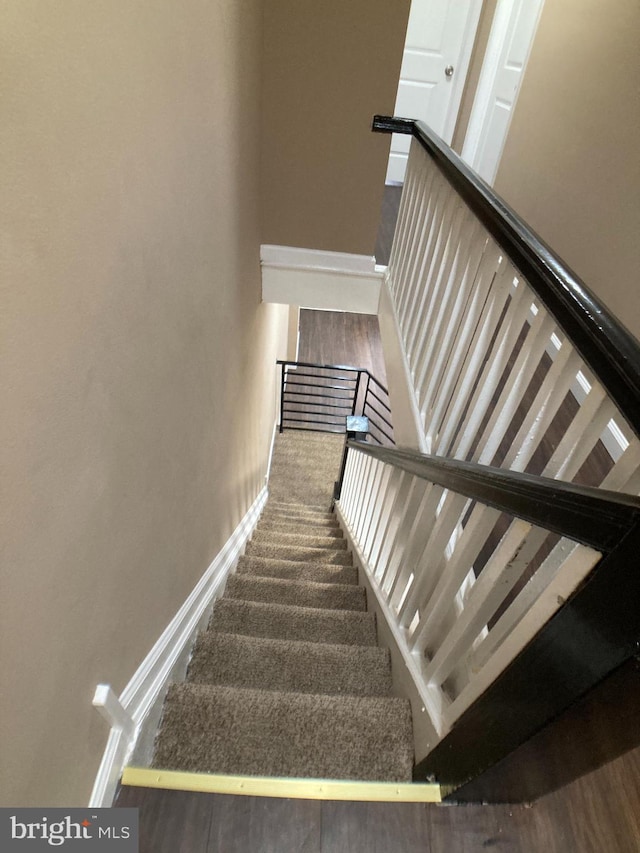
top-left (495, 0), bottom-right (640, 337)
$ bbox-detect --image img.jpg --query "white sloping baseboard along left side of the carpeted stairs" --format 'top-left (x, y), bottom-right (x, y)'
top-left (89, 486), bottom-right (267, 808)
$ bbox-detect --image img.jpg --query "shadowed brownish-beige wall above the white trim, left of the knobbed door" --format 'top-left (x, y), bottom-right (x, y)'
top-left (263, 0), bottom-right (410, 255)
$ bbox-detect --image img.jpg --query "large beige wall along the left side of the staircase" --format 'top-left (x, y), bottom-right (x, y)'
top-left (0, 0), bottom-right (288, 806)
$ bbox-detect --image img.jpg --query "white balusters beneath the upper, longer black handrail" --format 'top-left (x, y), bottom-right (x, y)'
top-left (388, 138), bottom-right (640, 493)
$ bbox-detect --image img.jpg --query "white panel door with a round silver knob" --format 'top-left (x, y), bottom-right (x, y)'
top-left (387, 0), bottom-right (482, 183)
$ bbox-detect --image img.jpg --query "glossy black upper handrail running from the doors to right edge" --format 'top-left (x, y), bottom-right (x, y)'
top-left (372, 115), bottom-right (640, 436)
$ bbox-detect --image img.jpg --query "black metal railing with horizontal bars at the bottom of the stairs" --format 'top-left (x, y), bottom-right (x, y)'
top-left (277, 361), bottom-right (395, 445)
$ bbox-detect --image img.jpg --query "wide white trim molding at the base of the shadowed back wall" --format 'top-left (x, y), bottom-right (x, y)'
top-left (260, 245), bottom-right (386, 314)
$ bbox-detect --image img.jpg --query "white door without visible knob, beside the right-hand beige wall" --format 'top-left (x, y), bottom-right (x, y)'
top-left (462, 0), bottom-right (544, 184)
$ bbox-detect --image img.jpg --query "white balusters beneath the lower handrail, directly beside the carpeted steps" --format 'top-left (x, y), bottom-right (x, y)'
top-left (337, 445), bottom-right (620, 747)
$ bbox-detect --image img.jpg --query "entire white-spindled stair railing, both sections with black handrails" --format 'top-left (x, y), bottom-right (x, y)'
top-left (337, 117), bottom-right (640, 781)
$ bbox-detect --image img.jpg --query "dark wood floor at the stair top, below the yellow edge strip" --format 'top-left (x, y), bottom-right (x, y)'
top-left (116, 767), bottom-right (640, 853)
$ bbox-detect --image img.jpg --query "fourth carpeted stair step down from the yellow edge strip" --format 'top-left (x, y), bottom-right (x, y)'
top-left (224, 574), bottom-right (367, 610)
